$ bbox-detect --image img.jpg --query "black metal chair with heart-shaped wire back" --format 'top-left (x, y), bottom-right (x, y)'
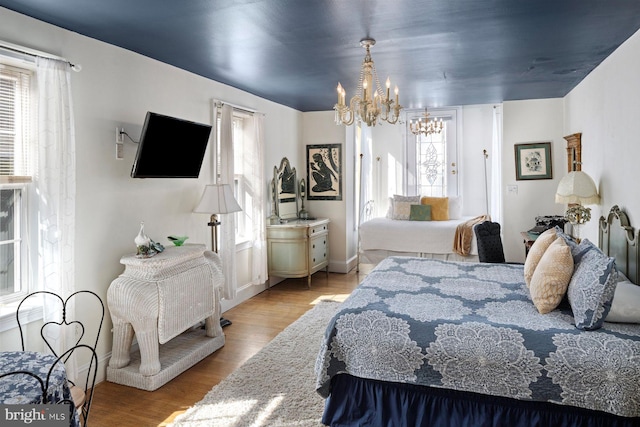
top-left (16, 290), bottom-right (105, 426)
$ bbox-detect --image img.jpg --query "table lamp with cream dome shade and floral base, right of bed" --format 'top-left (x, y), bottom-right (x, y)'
top-left (556, 171), bottom-right (600, 240)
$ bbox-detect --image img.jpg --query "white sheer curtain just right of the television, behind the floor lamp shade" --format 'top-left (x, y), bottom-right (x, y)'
top-left (219, 104), bottom-right (238, 299)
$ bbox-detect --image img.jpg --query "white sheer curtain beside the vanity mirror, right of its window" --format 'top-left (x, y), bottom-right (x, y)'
top-left (245, 113), bottom-right (268, 285)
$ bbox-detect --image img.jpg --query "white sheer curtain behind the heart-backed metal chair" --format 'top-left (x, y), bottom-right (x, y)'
top-left (35, 57), bottom-right (77, 378)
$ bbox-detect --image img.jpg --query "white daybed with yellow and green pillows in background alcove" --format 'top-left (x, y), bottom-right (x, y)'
top-left (358, 195), bottom-right (488, 265)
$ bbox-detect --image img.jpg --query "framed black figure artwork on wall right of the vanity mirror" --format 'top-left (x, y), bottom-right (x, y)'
top-left (307, 144), bottom-right (342, 200)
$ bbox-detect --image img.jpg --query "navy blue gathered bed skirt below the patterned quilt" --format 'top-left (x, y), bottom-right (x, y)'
top-left (322, 374), bottom-right (640, 427)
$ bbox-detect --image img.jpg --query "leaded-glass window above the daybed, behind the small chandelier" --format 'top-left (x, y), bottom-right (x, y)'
top-left (406, 110), bottom-right (458, 197)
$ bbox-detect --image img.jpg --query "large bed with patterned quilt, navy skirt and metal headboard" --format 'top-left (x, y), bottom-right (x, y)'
top-left (316, 207), bottom-right (640, 427)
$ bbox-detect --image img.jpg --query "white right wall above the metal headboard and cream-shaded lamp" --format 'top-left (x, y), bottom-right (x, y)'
top-left (564, 28), bottom-right (640, 236)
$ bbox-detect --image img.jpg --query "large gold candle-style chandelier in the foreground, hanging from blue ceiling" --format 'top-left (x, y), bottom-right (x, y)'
top-left (333, 39), bottom-right (402, 126)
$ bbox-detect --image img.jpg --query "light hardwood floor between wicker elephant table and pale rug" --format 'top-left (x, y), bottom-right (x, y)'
top-left (88, 266), bottom-right (368, 427)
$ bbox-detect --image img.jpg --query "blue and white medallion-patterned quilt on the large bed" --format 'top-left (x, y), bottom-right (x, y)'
top-left (316, 257), bottom-right (640, 417)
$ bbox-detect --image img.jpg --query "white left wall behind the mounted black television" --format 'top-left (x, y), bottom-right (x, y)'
top-left (0, 8), bottom-right (303, 378)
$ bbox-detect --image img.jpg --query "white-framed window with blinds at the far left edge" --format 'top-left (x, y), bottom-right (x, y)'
top-left (0, 62), bottom-right (35, 301)
